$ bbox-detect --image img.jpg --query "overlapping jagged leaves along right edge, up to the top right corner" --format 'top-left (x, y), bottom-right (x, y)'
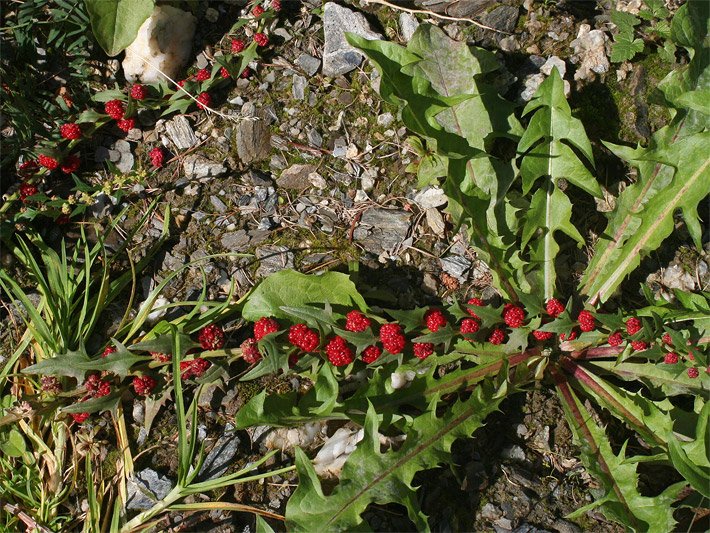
top-left (581, 2), bottom-right (710, 303)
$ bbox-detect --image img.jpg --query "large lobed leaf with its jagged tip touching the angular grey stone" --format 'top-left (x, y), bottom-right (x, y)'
top-left (347, 24), bottom-right (528, 300)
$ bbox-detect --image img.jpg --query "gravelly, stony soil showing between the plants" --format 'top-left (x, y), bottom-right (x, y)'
top-left (0, 0), bottom-right (710, 533)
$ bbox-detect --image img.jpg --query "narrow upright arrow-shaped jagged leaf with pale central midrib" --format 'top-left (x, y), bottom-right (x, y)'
top-left (518, 69), bottom-right (601, 300)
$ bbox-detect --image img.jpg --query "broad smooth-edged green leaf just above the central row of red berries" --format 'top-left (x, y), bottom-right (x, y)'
top-left (242, 270), bottom-right (367, 321)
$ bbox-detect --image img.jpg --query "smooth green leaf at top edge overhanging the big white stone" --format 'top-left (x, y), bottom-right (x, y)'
top-left (84, 0), bottom-right (155, 56)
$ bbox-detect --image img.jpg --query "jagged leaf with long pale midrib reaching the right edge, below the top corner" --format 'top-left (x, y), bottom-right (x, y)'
top-left (582, 128), bottom-right (710, 302)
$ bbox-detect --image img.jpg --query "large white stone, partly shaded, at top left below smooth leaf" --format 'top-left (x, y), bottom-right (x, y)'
top-left (123, 6), bottom-right (196, 83)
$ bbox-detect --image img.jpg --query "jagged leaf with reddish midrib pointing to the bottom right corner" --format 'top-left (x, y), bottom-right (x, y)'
top-left (556, 378), bottom-right (685, 533)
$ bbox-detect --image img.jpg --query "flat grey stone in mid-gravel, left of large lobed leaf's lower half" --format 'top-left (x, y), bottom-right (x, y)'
top-left (353, 208), bottom-right (412, 255)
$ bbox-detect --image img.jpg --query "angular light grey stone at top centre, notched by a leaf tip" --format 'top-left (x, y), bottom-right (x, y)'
top-left (323, 2), bottom-right (382, 78)
